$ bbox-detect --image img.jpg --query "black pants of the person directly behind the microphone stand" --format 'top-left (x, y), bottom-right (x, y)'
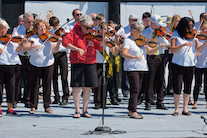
top-left (94, 63), bottom-right (108, 106)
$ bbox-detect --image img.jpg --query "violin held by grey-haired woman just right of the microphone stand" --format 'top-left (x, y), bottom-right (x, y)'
top-left (135, 36), bottom-right (158, 48)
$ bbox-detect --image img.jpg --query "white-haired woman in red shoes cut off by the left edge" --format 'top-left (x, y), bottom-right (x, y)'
top-left (0, 18), bottom-right (22, 117)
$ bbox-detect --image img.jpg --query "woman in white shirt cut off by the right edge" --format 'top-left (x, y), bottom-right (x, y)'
top-left (192, 21), bottom-right (207, 109)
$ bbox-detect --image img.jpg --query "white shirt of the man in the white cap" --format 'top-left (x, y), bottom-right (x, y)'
top-left (142, 26), bottom-right (170, 55)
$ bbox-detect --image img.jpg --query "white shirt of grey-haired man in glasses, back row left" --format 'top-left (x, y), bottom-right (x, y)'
top-left (12, 24), bottom-right (27, 56)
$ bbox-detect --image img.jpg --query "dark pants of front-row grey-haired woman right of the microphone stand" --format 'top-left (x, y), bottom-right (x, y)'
top-left (126, 71), bottom-right (144, 112)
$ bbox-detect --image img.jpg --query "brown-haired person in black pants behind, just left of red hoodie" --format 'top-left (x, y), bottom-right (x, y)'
top-left (49, 16), bottom-right (69, 105)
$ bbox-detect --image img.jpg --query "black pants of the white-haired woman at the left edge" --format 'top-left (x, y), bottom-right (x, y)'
top-left (0, 65), bottom-right (15, 103)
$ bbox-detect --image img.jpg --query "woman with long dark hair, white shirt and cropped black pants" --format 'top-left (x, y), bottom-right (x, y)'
top-left (170, 17), bottom-right (198, 116)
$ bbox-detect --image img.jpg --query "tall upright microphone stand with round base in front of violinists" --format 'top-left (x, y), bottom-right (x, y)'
top-left (95, 25), bottom-right (111, 133)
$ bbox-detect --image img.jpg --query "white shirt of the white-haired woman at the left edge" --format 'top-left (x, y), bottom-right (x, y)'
top-left (0, 42), bottom-right (22, 65)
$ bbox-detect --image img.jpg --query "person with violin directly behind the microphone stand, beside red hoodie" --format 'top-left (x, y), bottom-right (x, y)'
top-left (94, 22), bottom-right (118, 109)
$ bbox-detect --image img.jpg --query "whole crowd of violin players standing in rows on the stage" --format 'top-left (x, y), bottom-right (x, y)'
top-left (0, 9), bottom-right (207, 119)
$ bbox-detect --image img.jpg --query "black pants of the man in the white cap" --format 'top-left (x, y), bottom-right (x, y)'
top-left (145, 55), bottom-right (165, 104)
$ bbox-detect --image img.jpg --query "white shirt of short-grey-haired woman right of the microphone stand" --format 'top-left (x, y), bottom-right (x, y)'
top-left (122, 37), bottom-right (148, 71)
